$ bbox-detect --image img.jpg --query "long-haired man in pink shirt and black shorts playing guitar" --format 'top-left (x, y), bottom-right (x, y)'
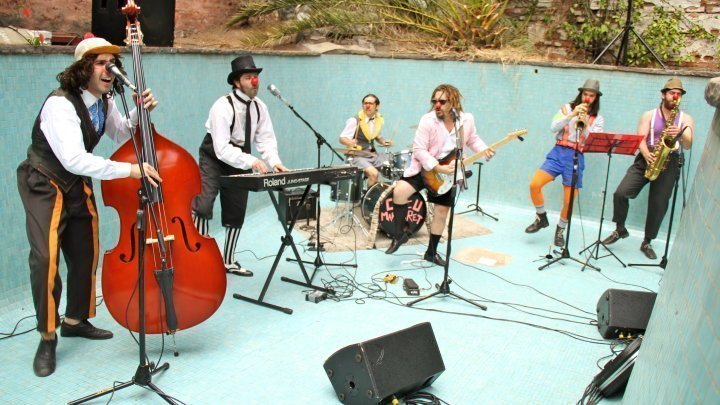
top-left (385, 84), bottom-right (495, 266)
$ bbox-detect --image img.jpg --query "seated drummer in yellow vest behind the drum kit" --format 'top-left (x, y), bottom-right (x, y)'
top-left (340, 94), bottom-right (392, 188)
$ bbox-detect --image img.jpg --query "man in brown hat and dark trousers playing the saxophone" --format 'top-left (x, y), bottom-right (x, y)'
top-left (602, 77), bottom-right (695, 260)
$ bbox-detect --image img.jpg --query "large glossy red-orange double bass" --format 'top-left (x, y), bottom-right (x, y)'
top-left (101, 0), bottom-right (227, 334)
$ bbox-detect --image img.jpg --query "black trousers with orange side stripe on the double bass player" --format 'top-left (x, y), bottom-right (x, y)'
top-left (17, 161), bottom-right (99, 333)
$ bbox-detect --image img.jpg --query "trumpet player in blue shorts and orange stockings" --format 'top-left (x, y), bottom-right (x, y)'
top-left (525, 79), bottom-right (605, 247)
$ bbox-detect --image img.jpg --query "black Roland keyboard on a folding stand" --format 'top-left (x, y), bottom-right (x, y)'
top-left (220, 165), bottom-right (358, 191)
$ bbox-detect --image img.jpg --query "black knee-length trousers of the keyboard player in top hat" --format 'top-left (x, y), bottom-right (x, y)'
top-left (192, 148), bottom-right (252, 228)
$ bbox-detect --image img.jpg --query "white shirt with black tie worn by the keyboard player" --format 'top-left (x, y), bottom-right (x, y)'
top-left (205, 89), bottom-right (282, 170)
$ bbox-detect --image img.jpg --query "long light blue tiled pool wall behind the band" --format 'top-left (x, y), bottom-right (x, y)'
top-left (0, 49), bottom-right (713, 313)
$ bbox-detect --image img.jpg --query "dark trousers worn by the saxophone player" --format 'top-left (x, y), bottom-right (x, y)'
top-left (613, 153), bottom-right (680, 240)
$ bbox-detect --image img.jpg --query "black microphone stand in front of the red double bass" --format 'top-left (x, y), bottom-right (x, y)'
top-left (68, 81), bottom-right (177, 405)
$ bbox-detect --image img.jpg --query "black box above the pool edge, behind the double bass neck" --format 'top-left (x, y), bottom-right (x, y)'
top-left (92, 0), bottom-right (175, 46)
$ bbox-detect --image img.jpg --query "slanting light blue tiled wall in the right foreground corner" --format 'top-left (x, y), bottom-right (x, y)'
top-left (624, 84), bottom-right (720, 404)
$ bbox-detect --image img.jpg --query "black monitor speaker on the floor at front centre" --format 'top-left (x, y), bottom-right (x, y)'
top-left (323, 322), bottom-right (445, 405)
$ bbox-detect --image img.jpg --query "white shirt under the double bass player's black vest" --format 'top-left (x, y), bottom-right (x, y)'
top-left (40, 90), bottom-right (138, 180)
